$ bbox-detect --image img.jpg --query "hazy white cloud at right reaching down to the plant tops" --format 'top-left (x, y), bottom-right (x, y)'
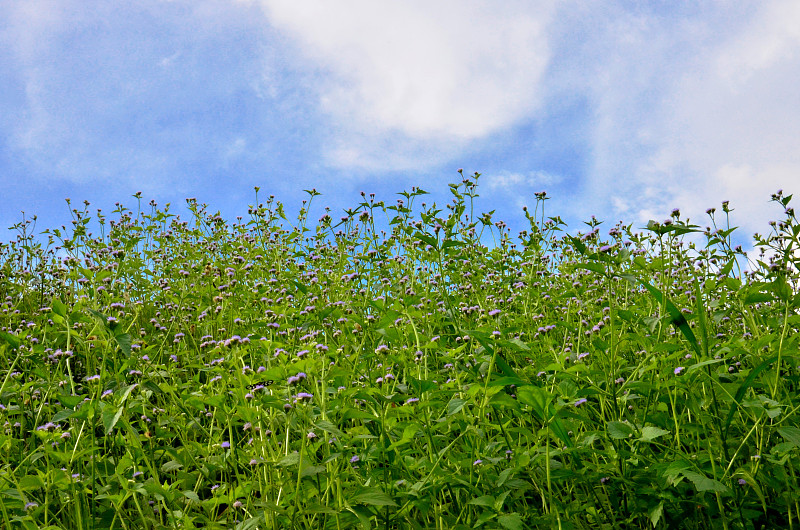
top-left (553, 1), bottom-right (800, 238)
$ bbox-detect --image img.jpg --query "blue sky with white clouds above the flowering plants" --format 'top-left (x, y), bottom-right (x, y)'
top-left (0, 0), bottom-right (800, 252)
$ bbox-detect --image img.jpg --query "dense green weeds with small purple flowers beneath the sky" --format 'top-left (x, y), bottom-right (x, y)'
top-left (0, 173), bottom-right (800, 530)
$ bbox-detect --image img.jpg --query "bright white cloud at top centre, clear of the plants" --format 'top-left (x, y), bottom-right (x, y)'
top-left (261, 0), bottom-right (553, 169)
